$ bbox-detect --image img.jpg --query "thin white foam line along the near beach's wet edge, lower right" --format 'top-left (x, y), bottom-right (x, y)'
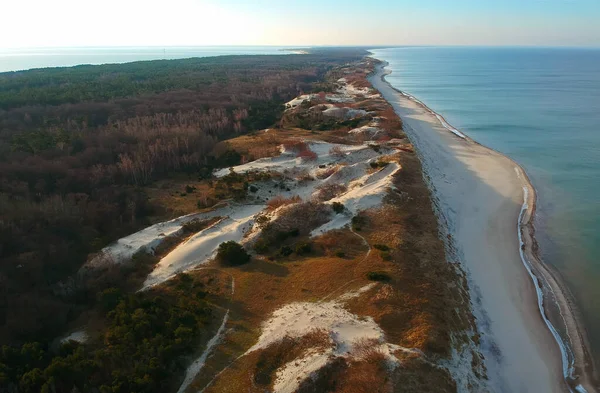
top-left (515, 184), bottom-right (587, 393)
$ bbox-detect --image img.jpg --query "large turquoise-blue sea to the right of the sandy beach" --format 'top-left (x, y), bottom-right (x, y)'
top-left (372, 47), bottom-right (600, 363)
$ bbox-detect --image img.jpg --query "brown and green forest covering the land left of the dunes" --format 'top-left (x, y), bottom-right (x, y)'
top-left (0, 49), bottom-right (363, 393)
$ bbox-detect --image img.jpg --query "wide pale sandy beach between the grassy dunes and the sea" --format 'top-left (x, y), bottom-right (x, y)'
top-left (371, 62), bottom-right (568, 393)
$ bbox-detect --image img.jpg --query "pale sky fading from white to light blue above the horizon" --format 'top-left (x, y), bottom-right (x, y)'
top-left (0, 0), bottom-right (600, 48)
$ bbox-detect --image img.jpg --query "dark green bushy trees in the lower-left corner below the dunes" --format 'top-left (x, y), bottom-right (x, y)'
top-left (0, 276), bottom-right (211, 393)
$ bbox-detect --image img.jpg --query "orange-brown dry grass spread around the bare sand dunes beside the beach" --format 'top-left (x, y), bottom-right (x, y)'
top-left (183, 61), bottom-right (473, 393)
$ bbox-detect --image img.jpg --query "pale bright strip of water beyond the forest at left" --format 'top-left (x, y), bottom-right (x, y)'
top-left (0, 46), bottom-right (289, 72)
